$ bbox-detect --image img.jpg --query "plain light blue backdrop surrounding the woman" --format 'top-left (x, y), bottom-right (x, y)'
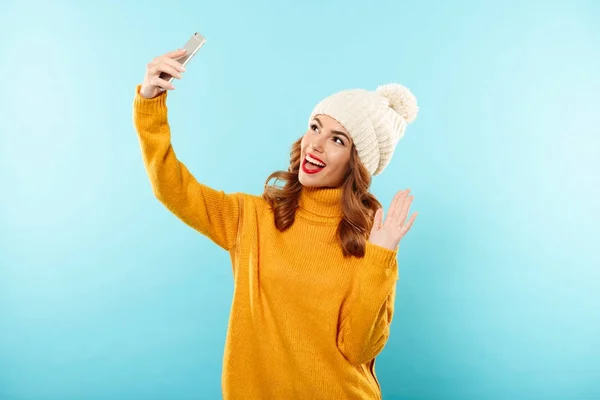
top-left (0, 0), bottom-right (600, 400)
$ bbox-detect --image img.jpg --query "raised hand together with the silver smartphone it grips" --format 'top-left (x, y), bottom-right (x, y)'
top-left (140, 33), bottom-right (206, 99)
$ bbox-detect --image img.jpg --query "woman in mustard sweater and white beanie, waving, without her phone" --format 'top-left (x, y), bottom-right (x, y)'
top-left (134, 50), bottom-right (418, 400)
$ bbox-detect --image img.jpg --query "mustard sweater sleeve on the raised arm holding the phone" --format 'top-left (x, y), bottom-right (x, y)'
top-left (133, 85), bottom-right (242, 250)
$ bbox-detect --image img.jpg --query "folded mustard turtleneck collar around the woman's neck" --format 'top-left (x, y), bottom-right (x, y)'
top-left (298, 186), bottom-right (344, 222)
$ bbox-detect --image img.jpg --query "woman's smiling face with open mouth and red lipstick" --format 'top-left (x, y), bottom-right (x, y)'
top-left (298, 115), bottom-right (352, 187)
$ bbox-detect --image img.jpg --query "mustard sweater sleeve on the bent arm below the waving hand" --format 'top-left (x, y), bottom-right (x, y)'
top-left (337, 241), bottom-right (398, 364)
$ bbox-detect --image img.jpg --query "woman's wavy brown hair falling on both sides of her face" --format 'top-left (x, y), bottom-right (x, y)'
top-left (262, 138), bottom-right (381, 257)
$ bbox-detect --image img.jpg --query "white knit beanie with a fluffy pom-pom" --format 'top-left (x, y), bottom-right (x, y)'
top-left (310, 83), bottom-right (419, 175)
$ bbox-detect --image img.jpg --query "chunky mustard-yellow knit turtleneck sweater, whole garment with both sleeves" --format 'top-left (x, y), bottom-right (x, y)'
top-left (133, 85), bottom-right (398, 400)
